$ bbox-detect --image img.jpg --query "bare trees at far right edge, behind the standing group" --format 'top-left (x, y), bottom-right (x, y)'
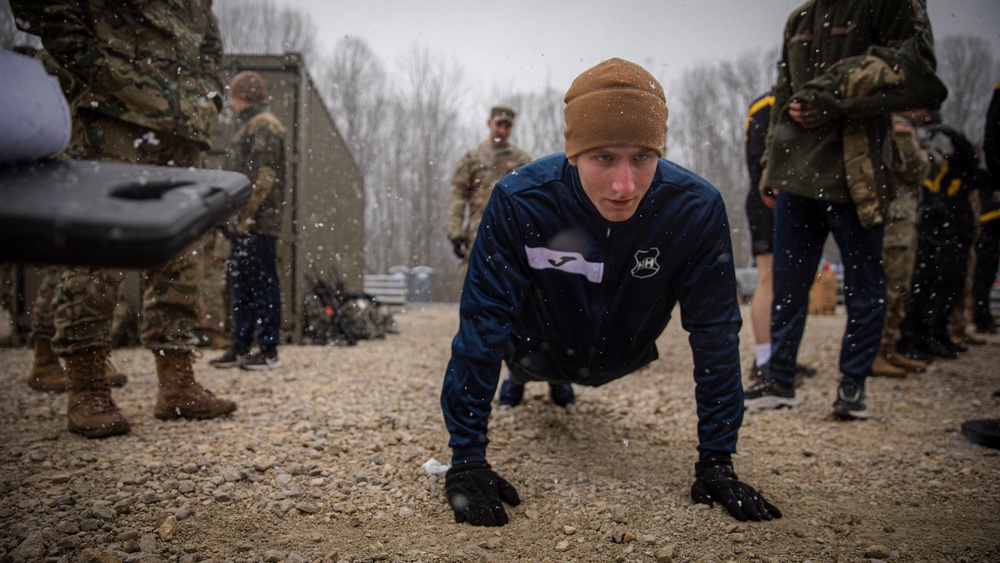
top-left (936, 35), bottom-right (1000, 144)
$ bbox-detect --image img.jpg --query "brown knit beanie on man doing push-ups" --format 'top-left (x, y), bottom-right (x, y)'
top-left (563, 58), bottom-right (667, 158)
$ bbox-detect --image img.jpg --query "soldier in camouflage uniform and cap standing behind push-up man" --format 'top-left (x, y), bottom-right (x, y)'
top-left (448, 106), bottom-right (532, 279)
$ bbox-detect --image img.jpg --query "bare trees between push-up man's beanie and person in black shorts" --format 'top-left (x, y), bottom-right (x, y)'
top-left (668, 51), bottom-right (778, 264)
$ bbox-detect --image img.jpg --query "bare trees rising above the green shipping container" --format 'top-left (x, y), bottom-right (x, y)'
top-left (213, 0), bottom-right (316, 61)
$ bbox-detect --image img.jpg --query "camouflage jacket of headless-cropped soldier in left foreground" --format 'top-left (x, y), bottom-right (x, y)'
top-left (11, 0), bottom-right (223, 149)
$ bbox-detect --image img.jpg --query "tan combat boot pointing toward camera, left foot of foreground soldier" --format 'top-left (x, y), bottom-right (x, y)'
top-left (66, 350), bottom-right (132, 438)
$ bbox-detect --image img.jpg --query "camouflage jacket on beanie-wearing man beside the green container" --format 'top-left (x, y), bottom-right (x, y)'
top-left (226, 102), bottom-right (285, 237)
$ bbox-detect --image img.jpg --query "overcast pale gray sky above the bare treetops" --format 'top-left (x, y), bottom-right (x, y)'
top-left (281, 0), bottom-right (1000, 104)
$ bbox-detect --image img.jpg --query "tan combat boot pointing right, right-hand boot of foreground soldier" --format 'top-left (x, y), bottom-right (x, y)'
top-left (153, 350), bottom-right (236, 420)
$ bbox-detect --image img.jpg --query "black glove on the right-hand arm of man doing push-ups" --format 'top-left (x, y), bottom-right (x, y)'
top-left (691, 459), bottom-right (781, 522)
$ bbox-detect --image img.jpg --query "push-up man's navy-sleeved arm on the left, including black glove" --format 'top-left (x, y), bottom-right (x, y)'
top-left (441, 189), bottom-right (530, 526)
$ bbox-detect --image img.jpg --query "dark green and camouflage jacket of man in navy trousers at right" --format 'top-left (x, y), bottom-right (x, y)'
top-left (761, 0), bottom-right (947, 212)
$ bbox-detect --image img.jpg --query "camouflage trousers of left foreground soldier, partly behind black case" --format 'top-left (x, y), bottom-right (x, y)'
top-left (52, 112), bottom-right (203, 356)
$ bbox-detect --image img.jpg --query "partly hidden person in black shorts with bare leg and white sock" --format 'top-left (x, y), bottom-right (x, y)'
top-left (743, 91), bottom-right (816, 385)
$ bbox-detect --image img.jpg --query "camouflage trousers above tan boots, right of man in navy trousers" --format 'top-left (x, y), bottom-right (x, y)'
top-left (882, 191), bottom-right (918, 346)
